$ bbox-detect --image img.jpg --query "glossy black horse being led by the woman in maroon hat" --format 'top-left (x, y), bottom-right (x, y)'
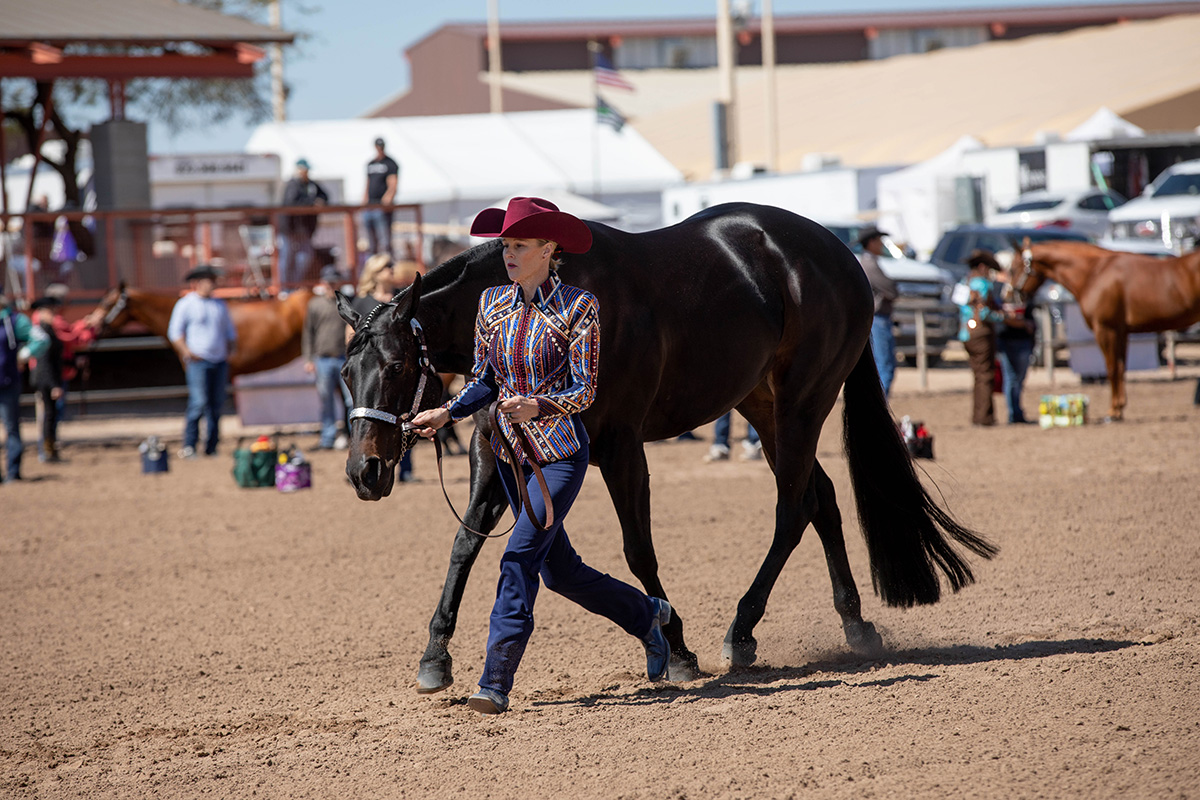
top-left (338, 204), bottom-right (996, 692)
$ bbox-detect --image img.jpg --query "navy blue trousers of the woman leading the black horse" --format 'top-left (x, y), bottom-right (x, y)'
top-left (479, 445), bottom-right (654, 694)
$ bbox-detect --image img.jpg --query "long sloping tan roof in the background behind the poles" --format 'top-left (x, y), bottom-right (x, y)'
top-left (494, 14), bottom-right (1200, 180)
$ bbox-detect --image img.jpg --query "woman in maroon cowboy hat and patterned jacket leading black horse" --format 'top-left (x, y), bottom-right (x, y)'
top-left (413, 197), bottom-right (671, 714)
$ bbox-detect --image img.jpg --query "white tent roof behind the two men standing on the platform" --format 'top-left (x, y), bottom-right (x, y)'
top-left (246, 108), bottom-right (683, 213)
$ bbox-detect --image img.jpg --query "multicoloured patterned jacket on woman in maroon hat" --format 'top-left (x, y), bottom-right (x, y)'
top-left (444, 273), bottom-right (600, 464)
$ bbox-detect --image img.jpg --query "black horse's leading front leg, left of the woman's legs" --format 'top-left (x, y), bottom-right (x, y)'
top-left (416, 427), bottom-right (509, 694)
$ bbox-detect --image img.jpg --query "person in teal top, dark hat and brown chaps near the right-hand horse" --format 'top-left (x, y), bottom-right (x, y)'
top-left (959, 249), bottom-right (1004, 426)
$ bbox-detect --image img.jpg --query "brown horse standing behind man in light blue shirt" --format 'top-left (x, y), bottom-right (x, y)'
top-left (98, 284), bottom-right (312, 377)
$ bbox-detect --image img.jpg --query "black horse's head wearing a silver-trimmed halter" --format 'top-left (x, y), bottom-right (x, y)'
top-left (335, 276), bottom-right (442, 500)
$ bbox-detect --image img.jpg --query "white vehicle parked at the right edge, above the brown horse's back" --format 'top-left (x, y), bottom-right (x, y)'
top-left (1109, 158), bottom-right (1200, 251)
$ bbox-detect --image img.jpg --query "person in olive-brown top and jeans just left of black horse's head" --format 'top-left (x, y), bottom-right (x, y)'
top-left (300, 266), bottom-right (354, 450)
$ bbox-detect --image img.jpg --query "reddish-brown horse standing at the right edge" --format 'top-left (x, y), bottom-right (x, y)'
top-left (1013, 240), bottom-right (1200, 420)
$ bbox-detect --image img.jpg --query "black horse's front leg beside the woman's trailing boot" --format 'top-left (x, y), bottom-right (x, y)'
top-left (592, 432), bottom-right (700, 680)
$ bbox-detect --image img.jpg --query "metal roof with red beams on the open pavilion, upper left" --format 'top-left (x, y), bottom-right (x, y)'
top-left (0, 0), bottom-right (295, 215)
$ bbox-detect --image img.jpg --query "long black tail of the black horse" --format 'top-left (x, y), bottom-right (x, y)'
top-left (842, 345), bottom-right (997, 608)
